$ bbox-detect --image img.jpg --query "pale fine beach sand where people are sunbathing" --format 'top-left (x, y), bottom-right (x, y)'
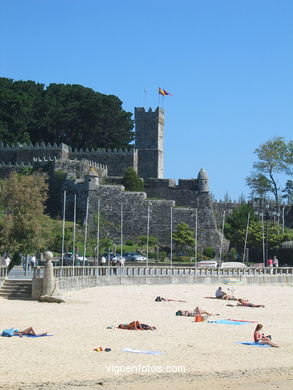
top-left (0, 284), bottom-right (293, 390)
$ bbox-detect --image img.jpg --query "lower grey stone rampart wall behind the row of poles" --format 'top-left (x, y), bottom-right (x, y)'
top-left (62, 176), bottom-right (227, 251)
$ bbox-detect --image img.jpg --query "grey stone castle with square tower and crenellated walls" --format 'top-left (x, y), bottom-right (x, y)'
top-left (0, 107), bottom-right (228, 253)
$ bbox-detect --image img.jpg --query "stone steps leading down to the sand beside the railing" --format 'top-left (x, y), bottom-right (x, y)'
top-left (0, 280), bottom-right (32, 300)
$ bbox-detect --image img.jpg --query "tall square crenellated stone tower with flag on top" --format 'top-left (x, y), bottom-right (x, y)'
top-left (135, 107), bottom-right (164, 179)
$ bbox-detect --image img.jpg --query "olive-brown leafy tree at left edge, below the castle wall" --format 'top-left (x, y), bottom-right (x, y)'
top-left (0, 173), bottom-right (52, 254)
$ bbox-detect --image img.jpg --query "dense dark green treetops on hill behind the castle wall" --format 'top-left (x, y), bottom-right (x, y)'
top-left (0, 78), bottom-right (134, 149)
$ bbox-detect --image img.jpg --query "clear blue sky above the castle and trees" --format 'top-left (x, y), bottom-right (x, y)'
top-left (0, 0), bottom-right (293, 200)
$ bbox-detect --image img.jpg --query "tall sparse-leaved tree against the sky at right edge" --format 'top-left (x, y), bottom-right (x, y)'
top-left (246, 137), bottom-right (293, 205)
